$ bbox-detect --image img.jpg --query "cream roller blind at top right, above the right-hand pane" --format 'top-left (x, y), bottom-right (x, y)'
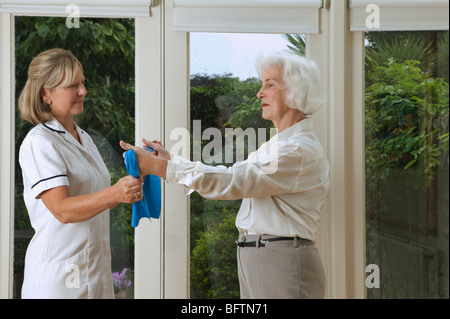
top-left (350, 0), bottom-right (449, 31)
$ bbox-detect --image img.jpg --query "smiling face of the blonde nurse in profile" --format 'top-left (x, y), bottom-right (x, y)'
top-left (43, 68), bottom-right (87, 118)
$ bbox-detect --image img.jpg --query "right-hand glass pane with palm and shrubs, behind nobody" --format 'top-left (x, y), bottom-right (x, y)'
top-left (365, 32), bottom-right (449, 298)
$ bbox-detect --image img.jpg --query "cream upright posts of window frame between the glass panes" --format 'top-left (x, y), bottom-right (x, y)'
top-left (0, 0), bottom-right (446, 299)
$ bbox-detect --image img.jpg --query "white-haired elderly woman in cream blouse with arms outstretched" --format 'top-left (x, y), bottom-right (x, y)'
top-left (121, 53), bottom-right (329, 298)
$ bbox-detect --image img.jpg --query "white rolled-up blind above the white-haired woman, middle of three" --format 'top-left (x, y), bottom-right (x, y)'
top-left (173, 0), bottom-right (322, 34)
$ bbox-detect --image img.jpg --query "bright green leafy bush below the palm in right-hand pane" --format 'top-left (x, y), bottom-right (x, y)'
top-left (366, 58), bottom-right (448, 183)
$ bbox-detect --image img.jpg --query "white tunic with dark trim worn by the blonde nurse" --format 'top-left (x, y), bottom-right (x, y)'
top-left (19, 118), bottom-right (114, 298)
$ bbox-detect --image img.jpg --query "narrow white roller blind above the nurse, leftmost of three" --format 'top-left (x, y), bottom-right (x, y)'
top-left (0, 0), bottom-right (152, 18)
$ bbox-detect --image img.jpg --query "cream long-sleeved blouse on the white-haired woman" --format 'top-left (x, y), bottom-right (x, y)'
top-left (166, 118), bottom-right (330, 241)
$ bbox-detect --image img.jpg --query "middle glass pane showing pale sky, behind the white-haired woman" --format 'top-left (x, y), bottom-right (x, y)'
top-left (190, 33), bottom-right (304, 299)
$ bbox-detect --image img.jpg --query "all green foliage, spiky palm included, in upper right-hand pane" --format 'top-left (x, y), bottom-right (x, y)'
top-left (365, 32), bottom-right (449, 225)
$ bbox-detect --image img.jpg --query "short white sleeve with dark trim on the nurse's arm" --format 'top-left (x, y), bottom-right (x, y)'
top-left (19, 134), bottom-right (69, 198)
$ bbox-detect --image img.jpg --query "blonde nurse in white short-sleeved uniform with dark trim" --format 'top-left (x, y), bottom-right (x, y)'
top-left (19, 49), bottom-right (142, 298)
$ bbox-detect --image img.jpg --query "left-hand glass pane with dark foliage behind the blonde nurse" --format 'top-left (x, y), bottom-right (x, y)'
top-left (13, 17), bottom-right (135, 298)
